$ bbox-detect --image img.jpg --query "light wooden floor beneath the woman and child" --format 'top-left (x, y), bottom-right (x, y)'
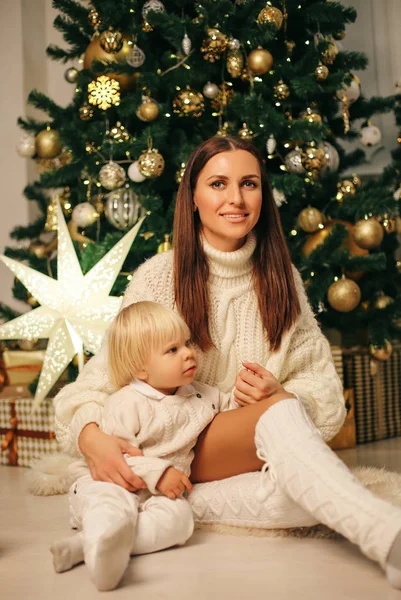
top-left (0, 438), bottom-right (401, 600)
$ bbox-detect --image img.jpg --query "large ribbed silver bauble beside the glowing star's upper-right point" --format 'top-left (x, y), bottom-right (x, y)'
top-left (104, 187), bottom-right (146, 231)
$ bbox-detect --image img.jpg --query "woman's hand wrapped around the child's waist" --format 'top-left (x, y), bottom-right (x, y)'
top-left (79, 423), bottom-right (146, 492)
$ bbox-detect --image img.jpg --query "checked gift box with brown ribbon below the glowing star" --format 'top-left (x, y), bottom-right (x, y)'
top-left (0, 386), bottom-right (59, 467)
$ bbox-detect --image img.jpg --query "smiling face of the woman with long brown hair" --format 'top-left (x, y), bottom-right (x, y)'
top-left (194, 150), bottom-right (262, 252)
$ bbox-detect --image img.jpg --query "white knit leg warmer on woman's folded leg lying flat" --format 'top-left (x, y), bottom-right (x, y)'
top-left (188, 472), bottom-right (318, 529)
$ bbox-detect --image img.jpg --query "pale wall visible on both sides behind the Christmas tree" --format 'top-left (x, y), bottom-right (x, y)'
top-left (0, 0), bottom-right (401, 309)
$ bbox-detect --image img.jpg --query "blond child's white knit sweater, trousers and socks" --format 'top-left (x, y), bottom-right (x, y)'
top-left (52, 380), bottom-right (237, 590)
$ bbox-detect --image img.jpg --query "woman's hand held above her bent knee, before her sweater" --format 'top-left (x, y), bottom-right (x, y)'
top-left (234, 361), bottom-right (295, 406)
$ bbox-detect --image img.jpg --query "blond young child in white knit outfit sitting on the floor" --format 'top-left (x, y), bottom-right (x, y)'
top-left (50, 302), bottom-right (237, 590)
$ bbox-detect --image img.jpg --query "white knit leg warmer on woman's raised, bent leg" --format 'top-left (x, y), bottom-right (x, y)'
top-left (255, 398), bottom-right (401, 569)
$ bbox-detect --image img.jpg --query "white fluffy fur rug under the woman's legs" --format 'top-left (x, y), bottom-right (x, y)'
top-left (25, 454), bottom-right (401, 538)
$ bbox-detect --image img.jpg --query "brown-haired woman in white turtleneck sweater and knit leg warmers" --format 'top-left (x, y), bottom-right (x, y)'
top-left (55, 137), bottom-right (401, 587)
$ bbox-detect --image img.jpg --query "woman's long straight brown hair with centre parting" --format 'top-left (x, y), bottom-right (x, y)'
top-left (173, 137), bottom-right (301, 352)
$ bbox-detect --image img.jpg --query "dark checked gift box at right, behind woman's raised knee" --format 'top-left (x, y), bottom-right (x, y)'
top-left (343, 343), bottom-right (401, 444)
